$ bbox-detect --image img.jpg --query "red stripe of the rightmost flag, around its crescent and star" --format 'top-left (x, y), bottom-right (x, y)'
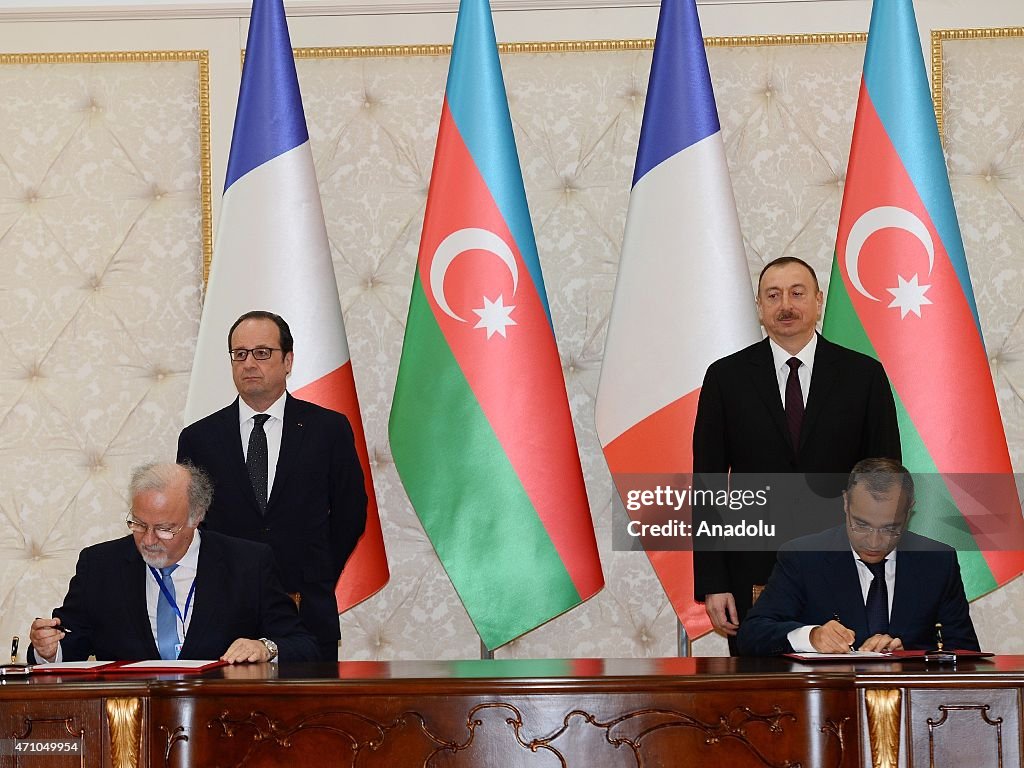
top-left (836, 84), bottom-right (1024, 561)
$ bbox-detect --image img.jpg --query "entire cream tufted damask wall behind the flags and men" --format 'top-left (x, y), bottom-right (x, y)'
top-left (0, 35), bottom-right (1024, 658)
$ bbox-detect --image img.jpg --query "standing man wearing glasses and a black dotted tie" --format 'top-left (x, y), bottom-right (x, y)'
top-left (178, 311), bottom-right (367, 662)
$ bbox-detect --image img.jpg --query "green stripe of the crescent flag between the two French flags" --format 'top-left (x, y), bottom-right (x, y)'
top-left (388, 272), bottom-right (581, 648)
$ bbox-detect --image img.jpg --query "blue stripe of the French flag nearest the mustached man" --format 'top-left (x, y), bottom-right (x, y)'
top-left (633, 0), bottom-right (719, 186)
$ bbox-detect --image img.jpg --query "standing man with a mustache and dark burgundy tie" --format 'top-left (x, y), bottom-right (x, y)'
top-left (693, 256), bottom-right (901, 653)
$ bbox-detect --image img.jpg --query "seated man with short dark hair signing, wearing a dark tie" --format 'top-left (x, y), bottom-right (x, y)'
top-left (737, 459), bottom-right (979, 655)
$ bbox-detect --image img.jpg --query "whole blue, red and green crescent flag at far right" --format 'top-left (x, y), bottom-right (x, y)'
top-left (824, 0), bottom-right (1024, 599)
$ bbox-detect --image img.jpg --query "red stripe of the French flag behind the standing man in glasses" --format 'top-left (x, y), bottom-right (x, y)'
top-left (293, 360), bottom-right (390, 613)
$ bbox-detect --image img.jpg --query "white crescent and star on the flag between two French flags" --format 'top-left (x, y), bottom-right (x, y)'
top-left (430, 227), bottom-right (519, 339)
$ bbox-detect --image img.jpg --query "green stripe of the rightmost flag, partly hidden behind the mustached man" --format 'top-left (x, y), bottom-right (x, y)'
top-left (821, 256), bottom-right (998, 600)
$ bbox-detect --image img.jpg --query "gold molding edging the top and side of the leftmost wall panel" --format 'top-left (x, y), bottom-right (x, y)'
top-left (0, 50), bottom-right (213, 284)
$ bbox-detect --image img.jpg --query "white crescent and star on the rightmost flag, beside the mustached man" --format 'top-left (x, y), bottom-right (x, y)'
top-left (846, 206), bottom-right (935, 319)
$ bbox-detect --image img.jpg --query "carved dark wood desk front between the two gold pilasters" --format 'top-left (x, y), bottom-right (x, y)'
top-left (151, 691), bottom-right (857, 768)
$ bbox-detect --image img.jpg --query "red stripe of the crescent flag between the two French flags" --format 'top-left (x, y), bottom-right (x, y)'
top-left (418, 100), bottom-right (604, 599)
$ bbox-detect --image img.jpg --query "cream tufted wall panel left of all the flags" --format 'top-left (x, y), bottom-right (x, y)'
top-left (0, 51), bottom-right (210, 655)
